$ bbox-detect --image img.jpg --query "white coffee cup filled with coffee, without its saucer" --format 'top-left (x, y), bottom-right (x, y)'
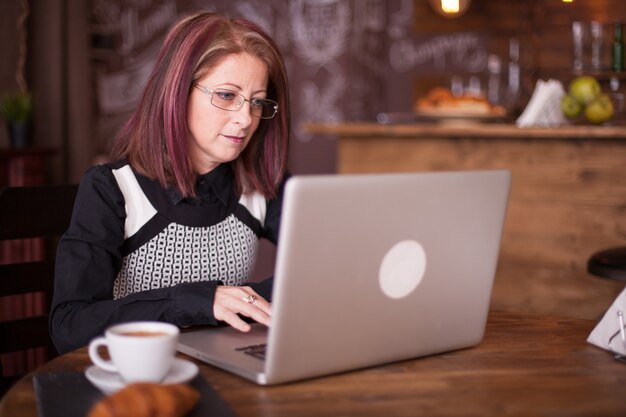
top-left (89, 321), bottom-right (180, 383)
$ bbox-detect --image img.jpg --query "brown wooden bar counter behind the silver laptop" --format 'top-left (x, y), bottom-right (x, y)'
top-left (307, 123), bottom-right (626, 318)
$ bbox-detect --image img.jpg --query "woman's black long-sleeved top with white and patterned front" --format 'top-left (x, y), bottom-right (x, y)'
top-left (50, 161), bottom-right (284, 353)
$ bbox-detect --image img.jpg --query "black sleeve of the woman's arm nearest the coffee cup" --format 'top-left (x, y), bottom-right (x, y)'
top-left (50, 166), bottom-right (220, 353)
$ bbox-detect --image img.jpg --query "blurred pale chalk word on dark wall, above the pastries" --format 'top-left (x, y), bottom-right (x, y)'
top-left (389, 32), bottom-right (488, 72)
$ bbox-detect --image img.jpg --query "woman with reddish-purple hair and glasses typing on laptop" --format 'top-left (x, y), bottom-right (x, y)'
top-left (50, 13), bottom-right (289, 353)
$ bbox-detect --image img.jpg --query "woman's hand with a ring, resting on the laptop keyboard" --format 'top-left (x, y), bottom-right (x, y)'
top-left (213, 285), bottom-right (272, 332)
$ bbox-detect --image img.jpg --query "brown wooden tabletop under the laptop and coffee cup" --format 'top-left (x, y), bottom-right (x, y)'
top-left (0, 312), bottom-right (626, 417)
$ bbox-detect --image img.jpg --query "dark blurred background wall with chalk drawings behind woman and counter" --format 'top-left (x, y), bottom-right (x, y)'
top-left (0, 0), bottom-right (626, 182)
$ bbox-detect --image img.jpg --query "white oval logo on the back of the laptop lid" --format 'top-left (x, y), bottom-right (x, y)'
top-left (378, 240), bottom-right (426, 298)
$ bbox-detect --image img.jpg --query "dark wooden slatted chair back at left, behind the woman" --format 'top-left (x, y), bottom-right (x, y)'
top-left (0, 185), bottom-right (78, 396)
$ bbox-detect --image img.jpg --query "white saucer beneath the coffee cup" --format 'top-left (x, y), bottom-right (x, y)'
top-left (85, 358), bottom-right (198, 395)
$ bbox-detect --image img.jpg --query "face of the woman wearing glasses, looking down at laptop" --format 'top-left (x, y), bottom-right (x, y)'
top-left (187, 53), bottom-right (268, 174)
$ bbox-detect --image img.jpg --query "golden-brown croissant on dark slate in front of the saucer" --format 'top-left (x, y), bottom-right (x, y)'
top-left (88, 383), bottom-right (200, 417)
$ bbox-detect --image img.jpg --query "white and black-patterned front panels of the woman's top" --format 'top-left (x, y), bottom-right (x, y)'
top-left (113, 165), bottom-right (266, 299)
